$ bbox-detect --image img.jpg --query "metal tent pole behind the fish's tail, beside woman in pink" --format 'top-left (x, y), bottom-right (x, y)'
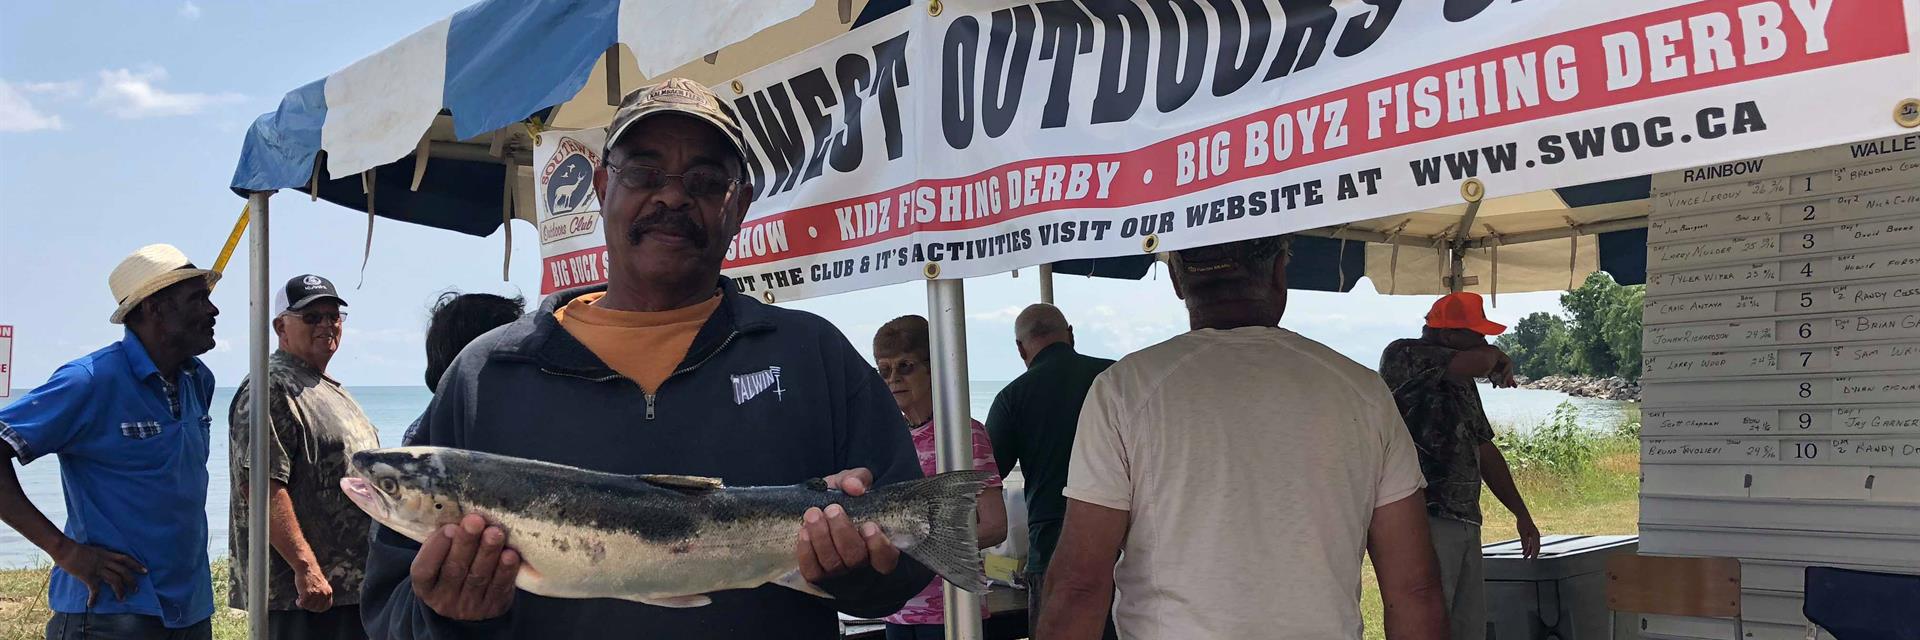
top-left (927, 278), bottom-right (990, 640)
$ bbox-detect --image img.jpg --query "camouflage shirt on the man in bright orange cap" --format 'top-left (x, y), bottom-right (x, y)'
top-left (1380, 338), bottom-right (1494, 525)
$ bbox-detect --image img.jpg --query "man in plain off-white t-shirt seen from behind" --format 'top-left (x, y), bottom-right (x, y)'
top-left (1035, 236), bottom-right (1448, 640)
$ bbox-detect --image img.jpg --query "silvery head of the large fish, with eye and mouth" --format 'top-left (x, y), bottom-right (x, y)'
top-left (340, 446), bottom-right (467, 540)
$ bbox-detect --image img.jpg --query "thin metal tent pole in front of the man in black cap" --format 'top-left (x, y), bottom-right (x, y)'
top-left (245, 192), bottom-right (273, 640)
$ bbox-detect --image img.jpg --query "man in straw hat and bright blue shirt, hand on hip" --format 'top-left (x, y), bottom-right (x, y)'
top-left (0, 244), bottom-right (221, 640)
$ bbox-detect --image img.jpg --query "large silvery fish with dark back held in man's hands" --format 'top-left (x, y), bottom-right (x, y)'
top-left (340, 446), bottom-right (989, 607)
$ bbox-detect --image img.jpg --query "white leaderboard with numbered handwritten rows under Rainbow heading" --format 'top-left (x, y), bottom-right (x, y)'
top-left (1642, 135), bottom-right (1920, 478)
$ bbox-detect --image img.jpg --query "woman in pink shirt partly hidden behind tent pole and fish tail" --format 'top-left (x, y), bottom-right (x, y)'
top-left (874, 315), bottom-right (1006, 640)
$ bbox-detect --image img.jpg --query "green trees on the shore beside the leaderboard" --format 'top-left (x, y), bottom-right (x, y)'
top-left (1494, 273), bottom-right (1647, 381)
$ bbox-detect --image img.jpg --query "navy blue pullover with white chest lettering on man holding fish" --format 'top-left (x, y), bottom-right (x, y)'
top-left (361, 281), bottom-right (933, 638)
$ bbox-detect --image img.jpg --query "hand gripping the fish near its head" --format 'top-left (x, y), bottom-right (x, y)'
top-left (411, 515), bottom-right (520, 621)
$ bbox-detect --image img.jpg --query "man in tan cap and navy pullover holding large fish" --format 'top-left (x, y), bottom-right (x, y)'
top-left (359, 79), bottom-right (944, 638)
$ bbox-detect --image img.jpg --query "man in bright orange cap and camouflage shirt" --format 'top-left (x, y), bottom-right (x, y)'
top-left (1380, 290), bottom-right (1540, 640)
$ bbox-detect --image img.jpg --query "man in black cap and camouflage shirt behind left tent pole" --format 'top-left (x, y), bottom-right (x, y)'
top-left (227, 273), bottom-right (380, 640)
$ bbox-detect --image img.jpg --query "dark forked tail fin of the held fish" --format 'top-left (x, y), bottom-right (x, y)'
top-left (874, 471), bottom-right (993, 594)
